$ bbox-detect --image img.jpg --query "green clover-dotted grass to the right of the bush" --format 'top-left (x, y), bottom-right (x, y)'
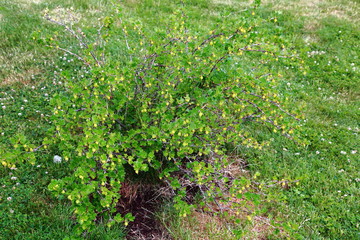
top-left (245, 2), bottom-right (360, 239)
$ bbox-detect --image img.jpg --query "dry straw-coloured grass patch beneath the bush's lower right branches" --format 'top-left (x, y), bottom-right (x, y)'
top-left (161, 154), bottom-right (286, 240)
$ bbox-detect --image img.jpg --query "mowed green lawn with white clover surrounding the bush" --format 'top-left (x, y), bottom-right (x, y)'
top-left (0, 0), bottom-right (360, 239)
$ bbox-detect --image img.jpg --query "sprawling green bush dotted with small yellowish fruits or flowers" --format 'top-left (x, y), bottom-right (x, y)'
top-left (8, 0), bottom-right (301, 236)
